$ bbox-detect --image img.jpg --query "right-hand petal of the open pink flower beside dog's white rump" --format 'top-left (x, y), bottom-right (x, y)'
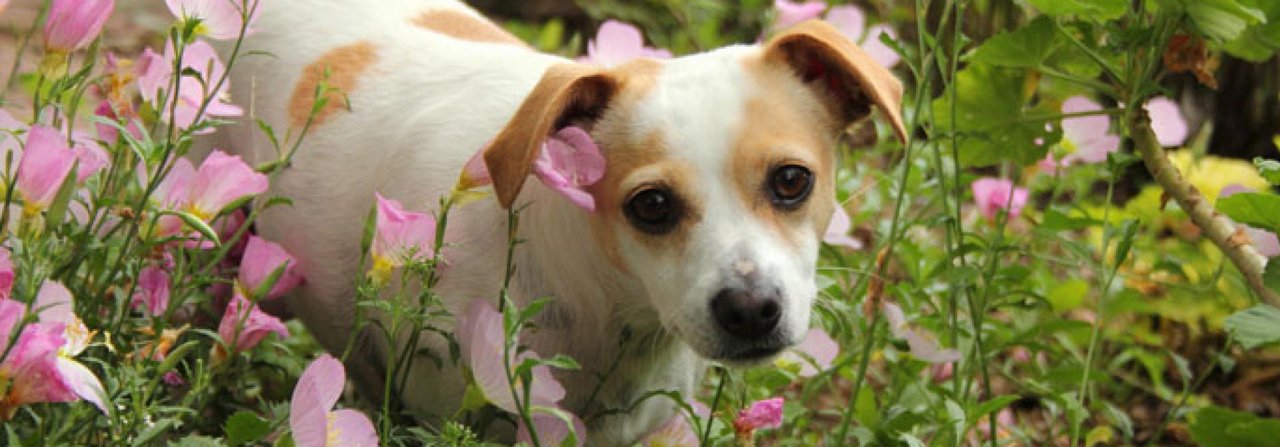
top-left (187, 150), bottom-right (268, 222)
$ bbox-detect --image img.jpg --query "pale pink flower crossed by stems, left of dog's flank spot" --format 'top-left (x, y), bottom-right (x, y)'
top-left (137, 41), bottom-right (243, 133)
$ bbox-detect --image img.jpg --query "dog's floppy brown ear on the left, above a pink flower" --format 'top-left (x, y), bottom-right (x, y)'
top-left (484, 64), bottom-right (618, 207)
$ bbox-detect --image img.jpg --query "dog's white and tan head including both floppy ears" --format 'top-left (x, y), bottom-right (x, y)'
top-left (485, 22), bottom-right (905, 364)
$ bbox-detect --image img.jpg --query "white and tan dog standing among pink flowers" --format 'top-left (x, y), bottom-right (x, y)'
top-left (224, 0), bottom-right (906, 446)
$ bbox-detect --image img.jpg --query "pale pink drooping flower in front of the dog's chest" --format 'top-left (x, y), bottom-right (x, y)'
top-left (457, 300), bottom-right (564, 412)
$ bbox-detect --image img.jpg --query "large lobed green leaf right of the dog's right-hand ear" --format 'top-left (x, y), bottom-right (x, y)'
top-left (933, 63), bottom-right (1061, 167)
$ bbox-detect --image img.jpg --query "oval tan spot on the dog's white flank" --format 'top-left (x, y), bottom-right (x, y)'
top-left (289, 41), bottom-right (378, 127)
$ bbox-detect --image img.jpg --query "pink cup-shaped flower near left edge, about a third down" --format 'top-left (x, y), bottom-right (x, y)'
top-left (18, 124), bottom-right (76, 209)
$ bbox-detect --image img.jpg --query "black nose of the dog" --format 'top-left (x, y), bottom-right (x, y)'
top-left (712, 288), bottom-right (782, 339)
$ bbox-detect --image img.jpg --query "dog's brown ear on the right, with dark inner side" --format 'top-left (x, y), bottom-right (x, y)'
top-left (764, 20), bottom-right (908, 143)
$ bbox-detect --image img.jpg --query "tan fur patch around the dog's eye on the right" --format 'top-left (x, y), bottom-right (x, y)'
top-left (727, 54), bottom-right (836, 245)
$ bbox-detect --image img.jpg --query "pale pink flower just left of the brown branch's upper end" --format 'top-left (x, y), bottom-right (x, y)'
top-left (1039, 96), bottom-right (1120, 170)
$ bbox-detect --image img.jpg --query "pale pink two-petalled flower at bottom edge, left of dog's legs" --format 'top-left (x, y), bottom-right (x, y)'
top-left (289, 354), bottom-right (378, 447)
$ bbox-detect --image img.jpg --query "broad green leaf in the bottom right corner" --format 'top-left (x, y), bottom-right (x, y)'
top-left (1190, 406), bottom-right (1280, 447)
